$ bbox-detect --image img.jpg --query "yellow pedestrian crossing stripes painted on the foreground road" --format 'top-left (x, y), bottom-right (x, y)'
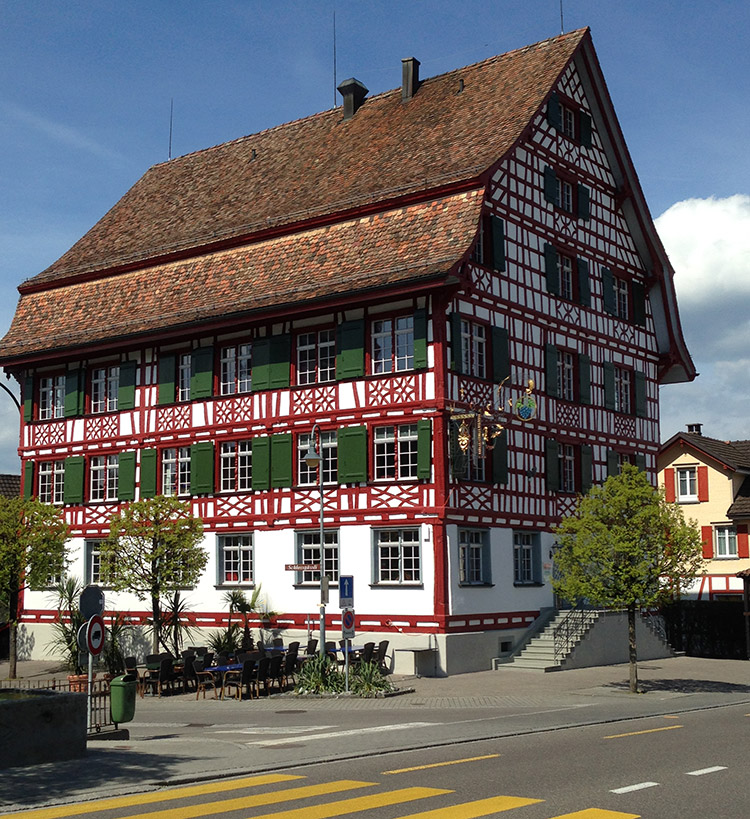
top-left (0, 768), bottom-right (639, 819)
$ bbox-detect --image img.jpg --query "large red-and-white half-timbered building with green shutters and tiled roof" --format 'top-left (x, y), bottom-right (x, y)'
top-left (0, 29), bottom-right (695, 673)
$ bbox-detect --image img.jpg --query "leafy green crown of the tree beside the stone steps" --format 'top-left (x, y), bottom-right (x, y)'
top-left (553, 464), bottom-right (703, 608)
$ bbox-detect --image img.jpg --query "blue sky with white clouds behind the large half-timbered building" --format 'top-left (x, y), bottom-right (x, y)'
top-left (0, 0), bottom-right (750, 471)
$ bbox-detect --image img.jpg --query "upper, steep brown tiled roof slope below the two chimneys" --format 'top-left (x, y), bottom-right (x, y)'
top-left (22, 29), bottom-right (588, 292)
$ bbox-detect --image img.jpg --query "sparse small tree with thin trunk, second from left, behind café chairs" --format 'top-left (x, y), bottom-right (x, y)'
top-left (101, 495), bottom-right (208, 653)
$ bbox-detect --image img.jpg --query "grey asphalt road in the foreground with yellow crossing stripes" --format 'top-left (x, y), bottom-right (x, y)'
top-left (2, 704), bottom-right (750, 819)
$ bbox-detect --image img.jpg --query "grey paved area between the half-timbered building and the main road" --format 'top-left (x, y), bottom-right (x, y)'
top-left (0, 657), bottom-right (750, 810)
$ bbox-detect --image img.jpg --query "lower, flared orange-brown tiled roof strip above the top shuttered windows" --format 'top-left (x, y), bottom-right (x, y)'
top-left (2, 194), bottom-right (483, 358)
